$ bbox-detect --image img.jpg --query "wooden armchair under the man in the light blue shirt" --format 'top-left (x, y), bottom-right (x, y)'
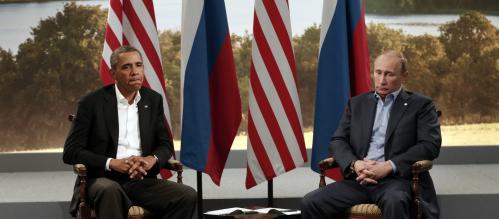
top-left (319, 157), bottom-right (433, 219)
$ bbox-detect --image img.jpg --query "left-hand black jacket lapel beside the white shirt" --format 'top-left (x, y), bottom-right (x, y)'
top-left (104, 86), bottom-right (119, 146)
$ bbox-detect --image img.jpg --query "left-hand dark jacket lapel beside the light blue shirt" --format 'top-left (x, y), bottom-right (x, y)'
top-left (361, 93), bottom-right (377, 157)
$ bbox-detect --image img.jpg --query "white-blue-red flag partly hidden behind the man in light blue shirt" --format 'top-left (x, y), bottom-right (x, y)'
top-left (310, 0), bottom-right (371, 180)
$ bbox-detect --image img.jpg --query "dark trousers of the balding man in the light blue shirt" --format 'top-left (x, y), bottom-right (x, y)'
top-left (301, 177), bottom-right (411, 219)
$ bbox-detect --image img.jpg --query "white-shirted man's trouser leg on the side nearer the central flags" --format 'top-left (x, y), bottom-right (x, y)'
top-left (123, 179), bottom-right (197, 219)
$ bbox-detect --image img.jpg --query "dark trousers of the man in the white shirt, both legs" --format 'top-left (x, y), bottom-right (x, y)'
top-left (88, 177), bottom-right (197, 219)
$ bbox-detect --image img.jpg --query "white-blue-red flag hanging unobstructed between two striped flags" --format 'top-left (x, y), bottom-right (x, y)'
top-left (180, 0), bottom-right (241, 185)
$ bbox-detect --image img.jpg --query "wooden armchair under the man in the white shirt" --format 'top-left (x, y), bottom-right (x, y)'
top-left (68, 114), bottom-right (183, 219)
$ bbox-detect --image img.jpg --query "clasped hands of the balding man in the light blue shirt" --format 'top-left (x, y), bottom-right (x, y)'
top-left (354, 160), bottom-right (393, 185)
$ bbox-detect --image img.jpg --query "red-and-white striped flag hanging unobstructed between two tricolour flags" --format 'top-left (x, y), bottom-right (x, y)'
top-left (246, 0), bottom-right (307, 188)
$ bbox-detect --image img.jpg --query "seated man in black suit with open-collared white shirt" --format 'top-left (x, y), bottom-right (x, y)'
top-left (63, 46), bottom-right (196, 219)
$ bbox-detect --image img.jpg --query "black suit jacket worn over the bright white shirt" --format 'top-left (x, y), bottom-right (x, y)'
top-left (63, 85), bottom-right (173, 216)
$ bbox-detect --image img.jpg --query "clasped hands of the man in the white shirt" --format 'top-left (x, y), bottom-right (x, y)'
top-left (109, 156), bottom-right (156, 179)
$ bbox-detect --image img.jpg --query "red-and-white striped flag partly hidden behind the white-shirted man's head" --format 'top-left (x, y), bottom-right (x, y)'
top-left (100, 0), bottom-right (172, 178)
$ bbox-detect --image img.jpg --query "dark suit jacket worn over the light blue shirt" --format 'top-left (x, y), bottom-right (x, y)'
top-left (330, 90), bottom-right (442, 218)
